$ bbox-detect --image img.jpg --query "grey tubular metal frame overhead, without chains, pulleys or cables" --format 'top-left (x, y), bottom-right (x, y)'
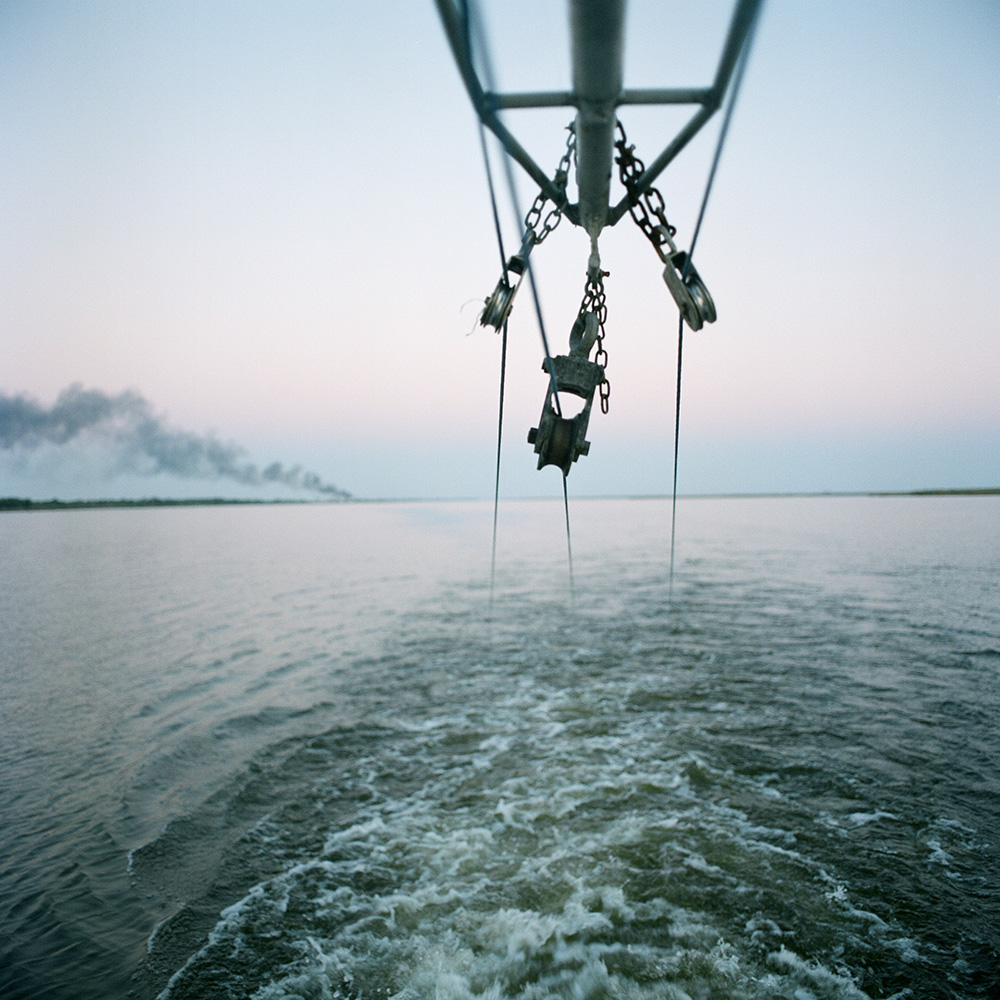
top-left (435, 0), bottom-right (763, 239)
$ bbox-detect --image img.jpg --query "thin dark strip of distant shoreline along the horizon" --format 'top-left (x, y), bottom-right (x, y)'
top-left (0, 486), bottom-right (1000, 513)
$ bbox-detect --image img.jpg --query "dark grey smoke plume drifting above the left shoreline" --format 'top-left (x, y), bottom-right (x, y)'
top-left (0, 384), bottom-right (350, 498)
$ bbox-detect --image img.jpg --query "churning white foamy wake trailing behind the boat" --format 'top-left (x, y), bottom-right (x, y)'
top-left (154, 620), bottom-right (936, 1000)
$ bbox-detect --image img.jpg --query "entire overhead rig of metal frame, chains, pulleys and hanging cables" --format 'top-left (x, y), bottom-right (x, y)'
top-left (435, 0), bottom-right (763, 602)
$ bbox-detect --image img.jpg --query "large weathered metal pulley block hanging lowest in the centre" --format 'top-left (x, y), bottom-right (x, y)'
top-left (528, 354), bottom-right (604, 476)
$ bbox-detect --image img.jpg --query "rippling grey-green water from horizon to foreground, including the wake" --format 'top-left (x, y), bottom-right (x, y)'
top-left (0, 497), bottom-right (1000, 1000)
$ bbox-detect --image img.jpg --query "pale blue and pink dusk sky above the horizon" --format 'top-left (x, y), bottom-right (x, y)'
top-left (0, 0), bottom-right (1000, 499)
